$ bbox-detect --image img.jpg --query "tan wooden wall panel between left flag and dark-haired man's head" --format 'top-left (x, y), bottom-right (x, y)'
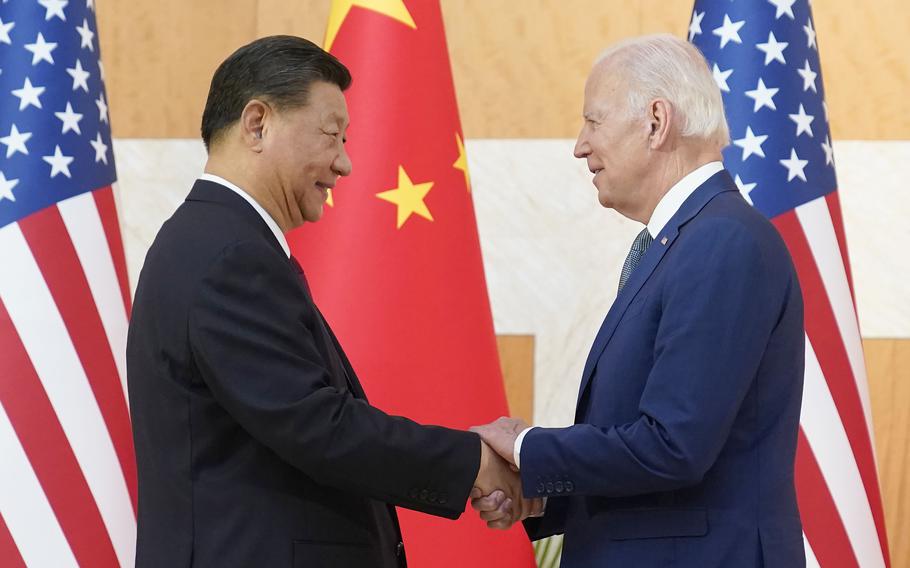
top-left (96, 0), bottom-right (257, 138)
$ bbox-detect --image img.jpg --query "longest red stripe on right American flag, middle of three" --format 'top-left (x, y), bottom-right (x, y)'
top-left (772, 207), bottom-right (888, 563)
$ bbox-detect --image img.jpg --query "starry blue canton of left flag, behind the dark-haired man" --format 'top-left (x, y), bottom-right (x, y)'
top-left (0, 0), bottom-right (116, 231)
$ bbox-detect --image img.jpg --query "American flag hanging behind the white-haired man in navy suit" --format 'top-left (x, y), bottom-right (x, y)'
top-left (689, 0), bottom-right (889, 567)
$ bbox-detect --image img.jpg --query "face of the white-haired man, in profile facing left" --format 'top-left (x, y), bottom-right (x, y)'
top-left (575, 61), bottom-right (650, 218)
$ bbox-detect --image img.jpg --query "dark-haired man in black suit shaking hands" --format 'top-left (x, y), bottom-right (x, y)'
top-left (127, 36), bottom-right (520, 568)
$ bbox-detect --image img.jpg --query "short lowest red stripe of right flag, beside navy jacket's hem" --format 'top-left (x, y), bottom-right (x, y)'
top-left (796, 428), bottom-right (859, 568)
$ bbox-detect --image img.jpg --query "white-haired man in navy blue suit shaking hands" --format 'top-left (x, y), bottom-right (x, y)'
top-left (474, 36), bottom-right (805, 568)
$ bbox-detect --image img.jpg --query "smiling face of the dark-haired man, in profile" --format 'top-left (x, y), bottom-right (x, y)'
top-left (262, 81), bottom-right (351, 227)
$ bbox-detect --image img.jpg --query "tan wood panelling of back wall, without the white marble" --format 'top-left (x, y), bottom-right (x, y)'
top-left (96, 0), bottom-right (910, 566)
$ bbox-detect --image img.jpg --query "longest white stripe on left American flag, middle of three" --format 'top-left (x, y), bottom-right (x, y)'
top-left (0, 223), bottom-right (136, 566)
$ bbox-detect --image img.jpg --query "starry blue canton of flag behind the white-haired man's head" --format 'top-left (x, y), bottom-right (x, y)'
top-left (689, 0), bottom-right (837, 217)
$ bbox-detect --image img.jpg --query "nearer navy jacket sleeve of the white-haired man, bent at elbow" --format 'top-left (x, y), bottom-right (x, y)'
top-left (521, 219), bottom-right (793, 497)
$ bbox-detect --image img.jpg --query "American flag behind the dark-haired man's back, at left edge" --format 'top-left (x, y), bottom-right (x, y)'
top-left (0, 0), bottom-right (136, 568)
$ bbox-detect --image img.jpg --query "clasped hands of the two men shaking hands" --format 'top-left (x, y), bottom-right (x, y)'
top-left (470, 417), bottom-right (544, 530)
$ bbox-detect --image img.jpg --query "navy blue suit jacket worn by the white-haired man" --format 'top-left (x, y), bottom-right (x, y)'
top-left (521, 172), bottom-right (805, 568)
